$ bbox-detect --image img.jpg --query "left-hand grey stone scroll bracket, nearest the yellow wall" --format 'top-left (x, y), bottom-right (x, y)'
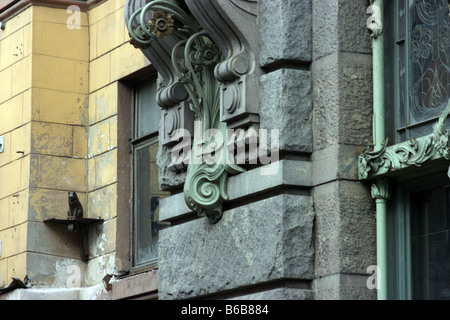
top-left (125, 0), bottom-right (194, 154)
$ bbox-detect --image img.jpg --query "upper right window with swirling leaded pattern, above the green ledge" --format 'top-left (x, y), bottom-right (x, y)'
top-left (385, 0), bottom-right (450, 143)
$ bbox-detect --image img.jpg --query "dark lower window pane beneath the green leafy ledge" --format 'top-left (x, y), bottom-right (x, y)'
top-left (388, 170), bottom-right (450, 300)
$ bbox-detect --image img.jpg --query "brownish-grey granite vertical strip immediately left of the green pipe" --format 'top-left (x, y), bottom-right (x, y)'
top-left (311, 0), bottom-right (376, 299)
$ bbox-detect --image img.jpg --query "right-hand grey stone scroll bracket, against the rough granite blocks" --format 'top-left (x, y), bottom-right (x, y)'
top-left (186, 0), bottom-right (260, 128)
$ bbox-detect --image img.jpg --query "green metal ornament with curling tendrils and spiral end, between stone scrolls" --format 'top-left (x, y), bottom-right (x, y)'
top-left (128, 0), bottom-right (247, 223)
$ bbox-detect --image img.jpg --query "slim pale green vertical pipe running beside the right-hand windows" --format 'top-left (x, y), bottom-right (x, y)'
top-left (368, 0), bottom-right (389, 300)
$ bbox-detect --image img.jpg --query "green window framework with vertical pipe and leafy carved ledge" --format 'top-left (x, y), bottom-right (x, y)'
top-left (358, 0), bottom-right (450, 299)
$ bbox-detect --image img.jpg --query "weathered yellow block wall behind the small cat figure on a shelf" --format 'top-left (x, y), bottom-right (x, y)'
top-left (0, 0), bottom-right (148, 287)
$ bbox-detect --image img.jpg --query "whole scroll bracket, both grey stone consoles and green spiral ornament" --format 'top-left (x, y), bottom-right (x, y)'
top-left (125, 0), bottom-right (258, 222)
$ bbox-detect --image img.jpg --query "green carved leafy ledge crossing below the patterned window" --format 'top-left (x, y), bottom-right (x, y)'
top-left (358, 101), bottom-right (450, 180)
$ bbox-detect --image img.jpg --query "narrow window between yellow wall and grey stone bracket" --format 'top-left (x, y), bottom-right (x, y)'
top-left (131, 76), bottom-right (171, 268)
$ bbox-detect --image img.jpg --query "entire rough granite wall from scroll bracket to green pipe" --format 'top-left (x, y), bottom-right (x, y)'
top-left (159, 0), bottom-right (376, 299)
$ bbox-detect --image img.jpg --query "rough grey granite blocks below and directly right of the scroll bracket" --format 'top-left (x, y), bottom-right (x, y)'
top-left (159, 0), bottom-right (315, 299)
